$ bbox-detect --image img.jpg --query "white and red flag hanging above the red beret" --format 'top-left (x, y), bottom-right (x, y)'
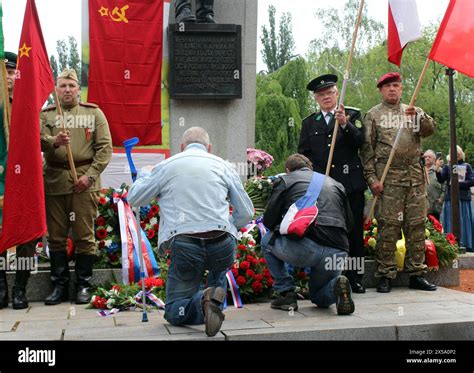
top-left (388, 0), bottom-right (421, 67)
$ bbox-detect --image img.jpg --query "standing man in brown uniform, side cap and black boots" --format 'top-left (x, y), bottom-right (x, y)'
top-left (41, 69), bottom-right (112, 305)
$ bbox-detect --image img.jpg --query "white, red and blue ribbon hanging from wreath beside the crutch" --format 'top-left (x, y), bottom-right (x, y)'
top-left (113, 192), bottom-right (160, 284)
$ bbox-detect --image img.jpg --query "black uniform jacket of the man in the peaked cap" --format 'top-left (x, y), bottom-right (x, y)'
top-left (298, 108), bottom-right (367, 193)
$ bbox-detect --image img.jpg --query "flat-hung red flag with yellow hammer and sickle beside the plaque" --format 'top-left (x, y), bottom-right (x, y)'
top-left (88, 0), bottom-right (164, 146)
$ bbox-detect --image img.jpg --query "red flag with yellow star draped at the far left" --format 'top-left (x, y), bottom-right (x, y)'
top-left (0, 0), bottom-right (54, 252)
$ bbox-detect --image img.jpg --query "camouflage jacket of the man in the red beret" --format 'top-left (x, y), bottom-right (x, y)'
top-left (361, 102), bottom-right (435, 186)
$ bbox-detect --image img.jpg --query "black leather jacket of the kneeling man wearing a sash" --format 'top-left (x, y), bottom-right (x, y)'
top-left (263, 167), bottom-right (353, 251)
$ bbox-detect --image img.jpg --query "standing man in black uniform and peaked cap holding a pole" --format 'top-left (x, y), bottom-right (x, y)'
top-left (298, 74), bottom-right (367, 293)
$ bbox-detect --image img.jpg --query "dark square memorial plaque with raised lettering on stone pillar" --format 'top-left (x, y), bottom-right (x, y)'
top-left (169, 23), bottom-right (242, 99)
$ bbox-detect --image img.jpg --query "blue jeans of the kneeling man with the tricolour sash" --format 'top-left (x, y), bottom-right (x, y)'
top-left (261, 232), bottom-right (347, 308)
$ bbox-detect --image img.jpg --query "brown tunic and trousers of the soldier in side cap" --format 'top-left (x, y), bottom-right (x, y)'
top-left (40, 103), bottom-right (112, 254)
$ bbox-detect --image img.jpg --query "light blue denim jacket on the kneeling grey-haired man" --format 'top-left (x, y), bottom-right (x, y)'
top-left (127, 143), bottom-right (254, 246)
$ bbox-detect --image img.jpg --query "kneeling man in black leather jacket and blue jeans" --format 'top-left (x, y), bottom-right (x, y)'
top-left (262, 154), bottom-right (354, 315)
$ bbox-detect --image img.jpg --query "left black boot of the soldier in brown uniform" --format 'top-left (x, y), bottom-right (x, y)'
top-left (44, 250), bottom-right (69, 306)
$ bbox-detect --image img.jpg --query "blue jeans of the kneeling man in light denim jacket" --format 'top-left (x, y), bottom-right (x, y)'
top-left (164, 234), bottom-right (236, 325)
